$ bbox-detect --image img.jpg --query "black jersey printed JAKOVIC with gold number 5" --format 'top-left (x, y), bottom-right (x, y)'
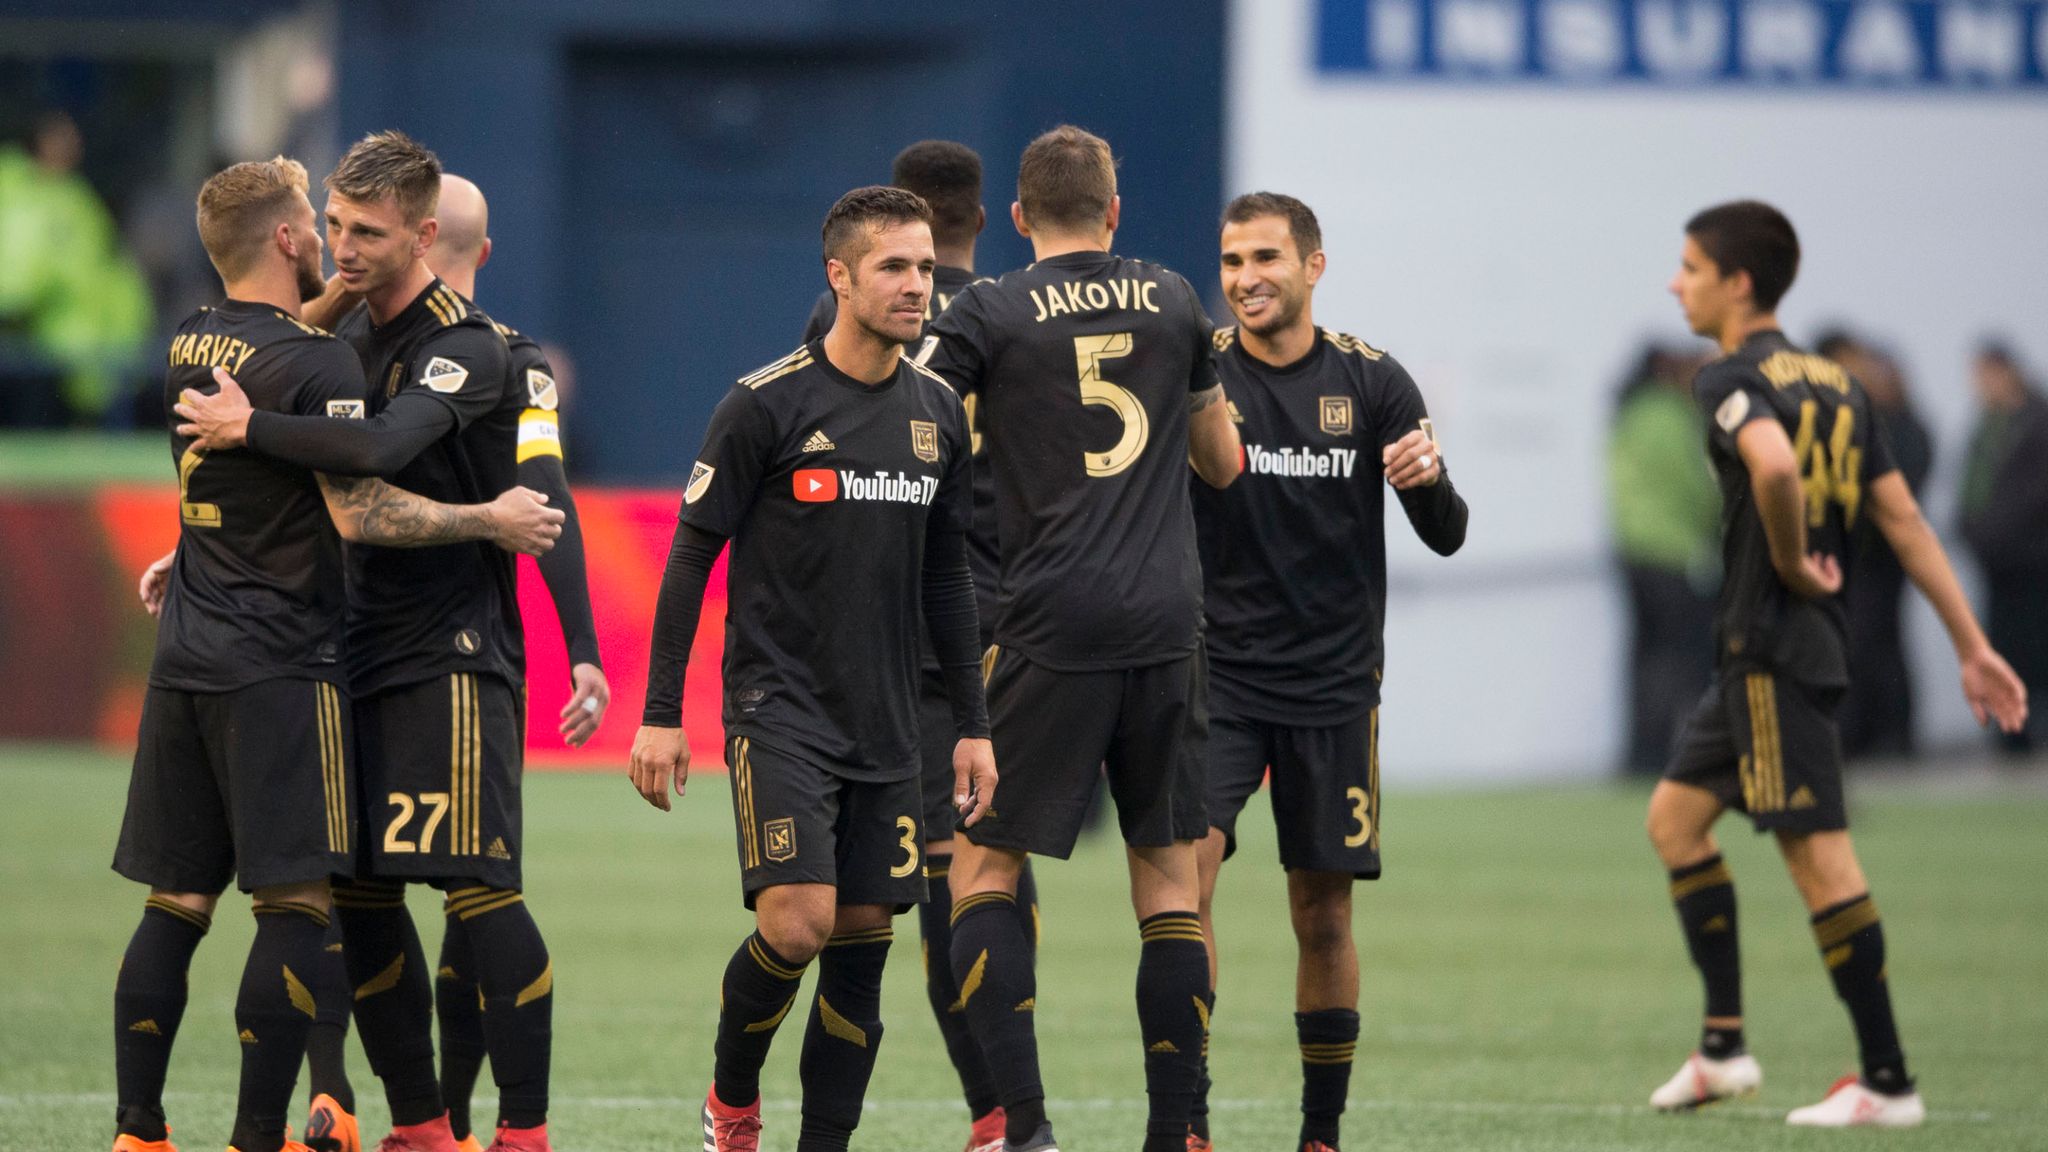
top-left (926, 252), bottom-right (1217, 670)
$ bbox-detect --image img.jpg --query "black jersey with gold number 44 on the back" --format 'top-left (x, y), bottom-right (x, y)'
top-left (1692, 330), bottom-right (1894, 687)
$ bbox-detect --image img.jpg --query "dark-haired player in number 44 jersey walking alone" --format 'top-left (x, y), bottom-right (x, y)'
top-left (1649, 201), bottom-right (2025, 1127)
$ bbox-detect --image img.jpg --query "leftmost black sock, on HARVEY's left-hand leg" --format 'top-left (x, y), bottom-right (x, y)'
top-left (115, 896), bottom-right (213, 1140)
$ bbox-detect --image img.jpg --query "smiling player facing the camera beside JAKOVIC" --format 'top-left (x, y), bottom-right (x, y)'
top-left (1188, 193), bottom-right (1468, 1152)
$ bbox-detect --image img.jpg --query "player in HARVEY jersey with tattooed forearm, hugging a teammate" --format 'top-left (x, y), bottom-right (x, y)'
top-left (115, 158), bottom-right (561, 1152)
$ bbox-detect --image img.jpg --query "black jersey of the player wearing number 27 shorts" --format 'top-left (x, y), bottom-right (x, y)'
top-left (340, 279), bottom-right (526, 695)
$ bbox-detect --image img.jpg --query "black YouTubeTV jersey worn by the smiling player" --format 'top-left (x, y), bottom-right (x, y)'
top-left (1190, 328), bottom-right (1466, 726)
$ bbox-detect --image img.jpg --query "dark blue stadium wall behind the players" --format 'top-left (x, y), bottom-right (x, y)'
top-left (338, 0), bottom-right (1225, 482)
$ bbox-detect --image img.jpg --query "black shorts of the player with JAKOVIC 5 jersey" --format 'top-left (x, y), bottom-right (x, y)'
top-left (967, 648), bottom-right (1208, 859)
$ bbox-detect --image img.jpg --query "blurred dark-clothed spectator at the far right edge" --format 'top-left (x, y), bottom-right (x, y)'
top-left (1962, 340), bottom-right (2048, 754)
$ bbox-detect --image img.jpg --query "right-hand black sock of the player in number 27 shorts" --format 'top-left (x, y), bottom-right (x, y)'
top-left (449, 888), bottom-right (555, 1127)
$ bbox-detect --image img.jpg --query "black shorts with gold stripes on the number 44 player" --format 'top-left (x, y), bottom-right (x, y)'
top-left (1665, 668), bottom-right (1849, 832)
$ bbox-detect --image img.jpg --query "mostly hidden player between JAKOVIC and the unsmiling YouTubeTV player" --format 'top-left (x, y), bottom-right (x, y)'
top-left (803, 139), bottom-right (1038, 1152)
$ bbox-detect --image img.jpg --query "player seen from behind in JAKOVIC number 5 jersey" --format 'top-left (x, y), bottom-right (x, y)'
top-left (928, 125), bottom-right (1239, 1152)
